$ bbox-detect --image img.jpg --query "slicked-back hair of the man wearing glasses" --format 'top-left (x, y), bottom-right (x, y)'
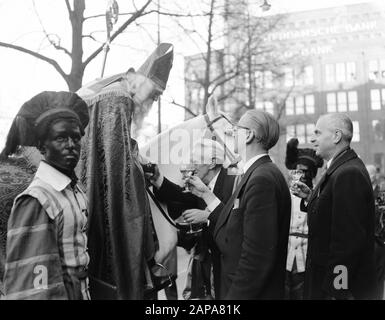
top-left (239, 110), bottom-right (280, 151)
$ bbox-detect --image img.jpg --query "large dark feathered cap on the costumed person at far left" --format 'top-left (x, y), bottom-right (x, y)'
top-left (6, 91), bottom-right (89, 154)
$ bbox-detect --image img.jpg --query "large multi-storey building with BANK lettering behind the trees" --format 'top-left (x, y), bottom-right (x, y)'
top-left (185, 3), bottom-right (385, 173)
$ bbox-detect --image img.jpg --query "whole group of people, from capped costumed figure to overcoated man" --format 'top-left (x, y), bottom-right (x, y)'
top-left (0, 44), bottom-right (385, 300)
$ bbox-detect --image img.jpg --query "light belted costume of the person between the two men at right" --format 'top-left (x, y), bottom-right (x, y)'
top-left (286, 195), bottom-right (308, 272)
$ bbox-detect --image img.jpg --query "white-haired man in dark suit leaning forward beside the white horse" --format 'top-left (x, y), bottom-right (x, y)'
top-left (147, 139), bottom-right (236, 298)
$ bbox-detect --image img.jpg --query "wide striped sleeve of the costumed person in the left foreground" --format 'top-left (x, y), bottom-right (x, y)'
top-left (4, 195), bottom-right (68, 300)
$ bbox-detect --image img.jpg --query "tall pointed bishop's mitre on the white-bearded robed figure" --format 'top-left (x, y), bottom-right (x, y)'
top-left (137, 43), bottom-right (174, 90)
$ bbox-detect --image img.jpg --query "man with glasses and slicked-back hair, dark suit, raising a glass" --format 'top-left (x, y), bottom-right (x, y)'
top-left (190, 110), bottom-right (291, 300)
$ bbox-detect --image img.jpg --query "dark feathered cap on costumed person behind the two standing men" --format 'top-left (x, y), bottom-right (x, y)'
top-left (285, 138), bottom-right (323, 177)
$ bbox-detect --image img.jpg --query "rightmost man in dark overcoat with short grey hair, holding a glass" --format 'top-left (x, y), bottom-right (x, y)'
top-left (292, 113), bottom-right (375, 299)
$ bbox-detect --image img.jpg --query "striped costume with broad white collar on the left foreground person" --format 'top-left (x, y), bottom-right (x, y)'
top-left (4, 162), bottom-right (89, 299)
